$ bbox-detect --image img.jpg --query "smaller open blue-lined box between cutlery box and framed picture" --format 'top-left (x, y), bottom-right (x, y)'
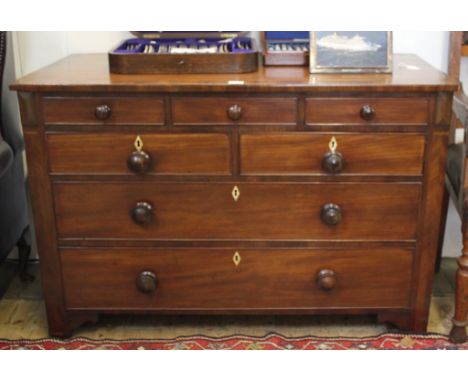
top-left (261, 31), bottom-right (309, 66)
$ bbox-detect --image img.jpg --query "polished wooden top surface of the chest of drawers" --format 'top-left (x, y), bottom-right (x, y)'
top-left (11, 54), bottom-right (458, 93)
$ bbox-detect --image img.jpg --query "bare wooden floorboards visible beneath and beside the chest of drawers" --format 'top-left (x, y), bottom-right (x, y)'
top-left (0, 258), bottom-right (456, 339)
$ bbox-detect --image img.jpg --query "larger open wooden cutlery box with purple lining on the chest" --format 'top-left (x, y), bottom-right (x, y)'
top-left (109, 32), bottom-right (258, 74)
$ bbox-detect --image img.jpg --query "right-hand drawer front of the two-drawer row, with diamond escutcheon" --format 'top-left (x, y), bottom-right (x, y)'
top-left (241, 133), bottom-right (425, 175)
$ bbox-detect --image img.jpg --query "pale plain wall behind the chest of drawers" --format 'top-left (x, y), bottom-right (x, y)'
top-left (4, 31), bottom-right (468, 256)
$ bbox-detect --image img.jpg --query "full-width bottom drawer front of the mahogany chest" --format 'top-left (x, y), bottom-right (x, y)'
top-left (60, 247), bottom-right (413, 311)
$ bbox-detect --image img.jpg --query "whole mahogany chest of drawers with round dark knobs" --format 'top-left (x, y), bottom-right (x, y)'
top-left (12, 55), bottom-right (457, 336)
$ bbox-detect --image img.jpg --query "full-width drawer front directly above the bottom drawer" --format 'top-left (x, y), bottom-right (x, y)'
top-left (54, 182), bottom-right (420, 240)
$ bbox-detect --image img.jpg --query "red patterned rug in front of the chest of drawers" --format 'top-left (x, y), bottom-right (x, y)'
top-left (0, 333), bottom-right (468, 350)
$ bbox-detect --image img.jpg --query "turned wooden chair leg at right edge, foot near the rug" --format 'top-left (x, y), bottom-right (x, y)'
top-left (450, 216), bottom-right (468, 343)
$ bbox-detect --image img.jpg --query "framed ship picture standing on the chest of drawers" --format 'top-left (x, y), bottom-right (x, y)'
top-left (310, 31), bottom-right (393, 73)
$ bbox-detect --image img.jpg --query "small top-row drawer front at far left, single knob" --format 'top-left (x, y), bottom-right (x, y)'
top-left (42, 97), bottom-right (165, 125)
